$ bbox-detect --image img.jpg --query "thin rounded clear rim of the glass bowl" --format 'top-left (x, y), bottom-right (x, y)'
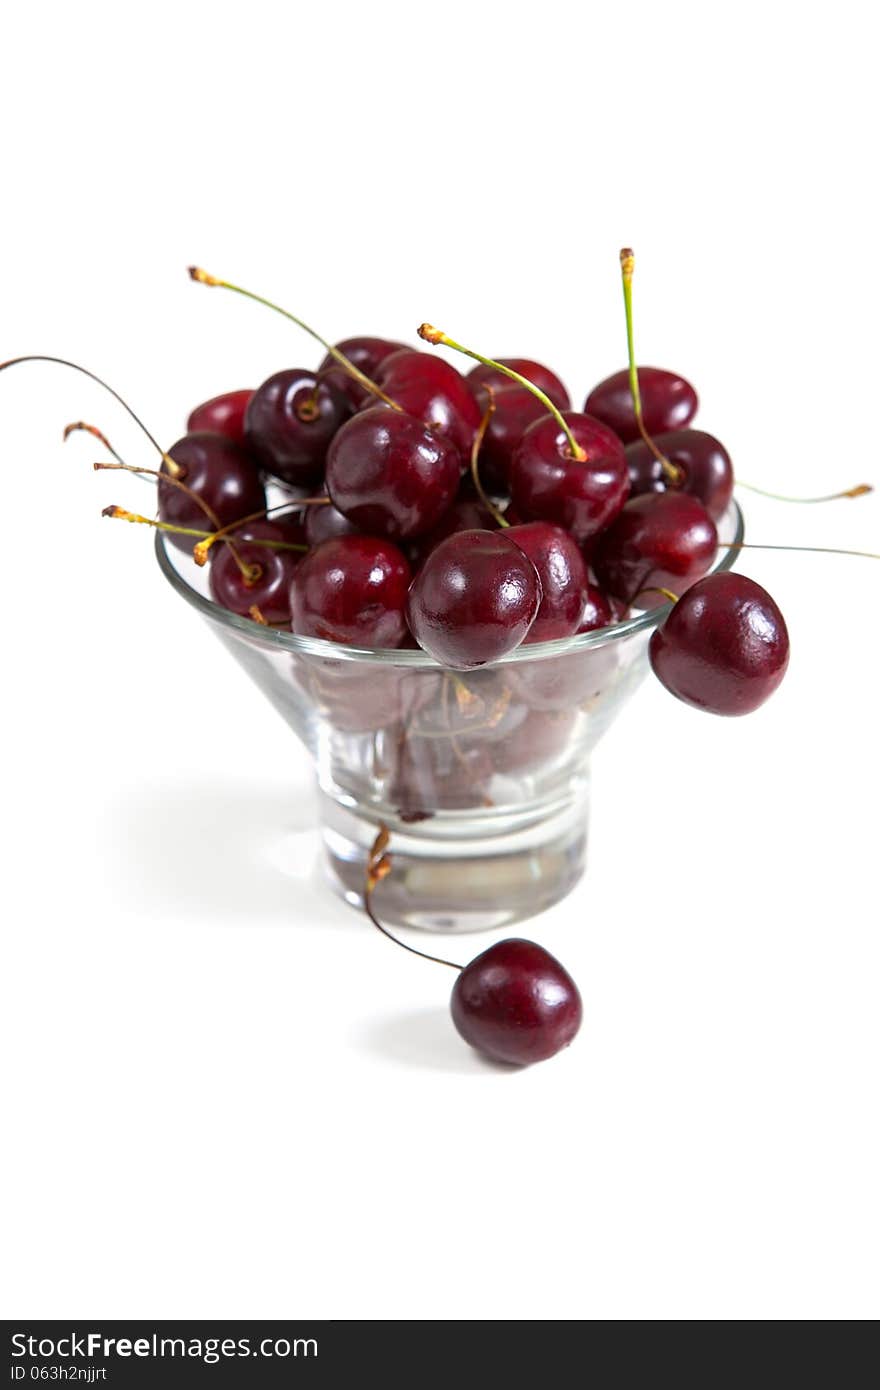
top-left (156, 498), bottom-right (745, 670)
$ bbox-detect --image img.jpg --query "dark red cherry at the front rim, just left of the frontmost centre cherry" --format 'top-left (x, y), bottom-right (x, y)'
top-left (291, 535), bottom-right (410, 646)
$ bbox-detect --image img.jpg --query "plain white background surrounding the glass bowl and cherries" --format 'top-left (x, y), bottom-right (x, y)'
top-left (0, 0), bottom-right (880, 1319)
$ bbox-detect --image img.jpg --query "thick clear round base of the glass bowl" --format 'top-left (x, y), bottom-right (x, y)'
top-left (321, 777), bottom-right (589, 933)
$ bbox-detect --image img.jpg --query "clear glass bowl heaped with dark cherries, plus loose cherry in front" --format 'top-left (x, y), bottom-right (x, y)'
top-left (10, 250), bottom-right (869, 1062)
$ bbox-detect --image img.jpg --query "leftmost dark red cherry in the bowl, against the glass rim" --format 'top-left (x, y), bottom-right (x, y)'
top-left (158, 431), bottom-right (266, 550)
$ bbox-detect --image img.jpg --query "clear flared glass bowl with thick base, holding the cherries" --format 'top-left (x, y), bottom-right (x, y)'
top-left (156, 503), bottom-right (744, 931)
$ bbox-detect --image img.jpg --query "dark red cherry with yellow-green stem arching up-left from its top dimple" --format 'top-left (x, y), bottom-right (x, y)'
top-left (510, 410), bottom-right (630, 542)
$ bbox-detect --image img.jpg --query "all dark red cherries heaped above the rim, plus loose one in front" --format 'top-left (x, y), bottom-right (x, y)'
top-left (0, 252), bottom-right (811, 1063)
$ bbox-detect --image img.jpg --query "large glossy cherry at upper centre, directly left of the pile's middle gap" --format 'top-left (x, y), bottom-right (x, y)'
top-left (327, 406), bottom-right (462, 539)
